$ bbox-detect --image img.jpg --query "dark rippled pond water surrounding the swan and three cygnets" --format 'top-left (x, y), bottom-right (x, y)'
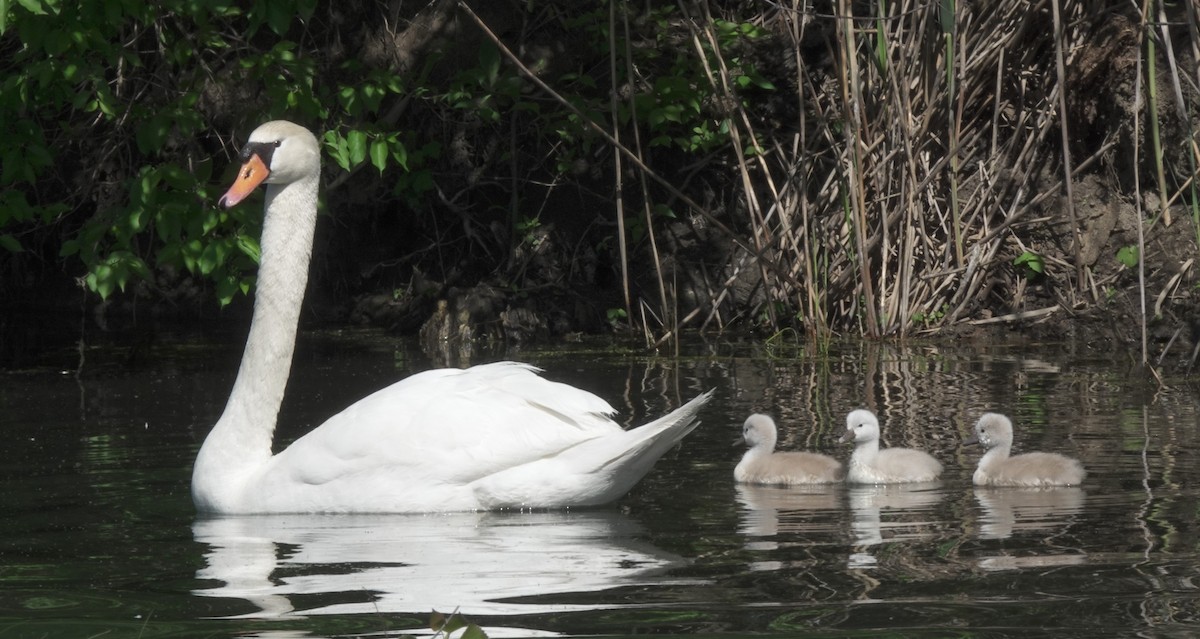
top-left (0, 333), bottom-right (1200, 639)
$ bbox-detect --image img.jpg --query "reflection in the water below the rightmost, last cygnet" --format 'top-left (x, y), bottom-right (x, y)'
top-left (974, 486), bottom-right (1087, 571)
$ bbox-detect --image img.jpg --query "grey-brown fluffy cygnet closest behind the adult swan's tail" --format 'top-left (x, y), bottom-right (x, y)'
top-left (733, 414), bottom-right (842, 485)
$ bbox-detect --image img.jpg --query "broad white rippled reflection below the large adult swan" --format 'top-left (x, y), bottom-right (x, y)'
top-left (192, 512), bottom-right (684, 619)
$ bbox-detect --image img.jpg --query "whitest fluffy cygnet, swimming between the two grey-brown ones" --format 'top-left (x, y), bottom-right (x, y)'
top-left (841, 408), bottom-right (942, 484)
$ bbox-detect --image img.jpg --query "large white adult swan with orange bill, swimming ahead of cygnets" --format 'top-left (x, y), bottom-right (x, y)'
top-left (192, 121), bottom-right (712, 514)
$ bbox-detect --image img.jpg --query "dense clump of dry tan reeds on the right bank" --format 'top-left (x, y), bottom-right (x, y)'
top-left (710, 0), bottom-right (1200, 343)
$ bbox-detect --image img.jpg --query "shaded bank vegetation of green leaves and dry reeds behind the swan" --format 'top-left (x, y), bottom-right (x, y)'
top-left (0, 0), bottom-right (1200, 371)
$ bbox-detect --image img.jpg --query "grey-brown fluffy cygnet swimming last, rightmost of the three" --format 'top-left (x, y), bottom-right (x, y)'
top-left (964, 413), bottom-right (1087, 486)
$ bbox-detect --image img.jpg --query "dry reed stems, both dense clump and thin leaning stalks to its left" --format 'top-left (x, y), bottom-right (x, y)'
top-left (461, 0), bottom-right (1200, 343)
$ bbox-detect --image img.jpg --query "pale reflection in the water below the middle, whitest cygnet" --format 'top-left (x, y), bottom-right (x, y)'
top-left (847, 482), bottom-right (946, 568)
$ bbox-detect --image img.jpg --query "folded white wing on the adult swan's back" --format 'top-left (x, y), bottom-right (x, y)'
top-left (270, 362), bottom-right (622, 485)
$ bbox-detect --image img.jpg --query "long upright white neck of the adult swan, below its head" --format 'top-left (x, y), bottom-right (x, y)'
top-left (192, 174), bottom-right (318, 512)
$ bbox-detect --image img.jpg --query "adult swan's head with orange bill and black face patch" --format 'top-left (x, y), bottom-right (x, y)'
top-left (217, 120), bottom-right (320, 209)
